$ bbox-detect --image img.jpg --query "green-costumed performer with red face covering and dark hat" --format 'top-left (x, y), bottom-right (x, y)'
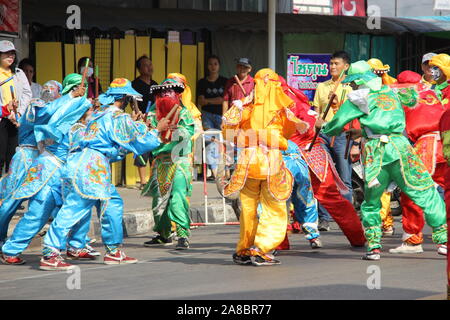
top-left (142, 79), bottom-right (194, 249)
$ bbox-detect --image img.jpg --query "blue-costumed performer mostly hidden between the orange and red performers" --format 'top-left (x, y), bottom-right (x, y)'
top-left (281, 140), bottom-right (322, 249)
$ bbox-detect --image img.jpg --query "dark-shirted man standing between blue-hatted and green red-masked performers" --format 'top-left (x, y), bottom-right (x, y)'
top-left (131, 56), bottom-right (158, 189)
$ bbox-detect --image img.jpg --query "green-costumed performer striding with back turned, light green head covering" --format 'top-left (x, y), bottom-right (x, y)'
top-left (323, 61), bottom-right (447, 260)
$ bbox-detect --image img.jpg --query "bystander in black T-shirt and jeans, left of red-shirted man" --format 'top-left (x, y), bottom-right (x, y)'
top-left (197, 55), bottom-right (227, 130)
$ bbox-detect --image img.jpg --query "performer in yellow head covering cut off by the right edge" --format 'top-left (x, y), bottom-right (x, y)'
top-left (428, 53), bottom-right (450, 109)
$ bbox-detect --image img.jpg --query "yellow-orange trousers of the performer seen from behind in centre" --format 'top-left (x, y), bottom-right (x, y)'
top-left (236, 178), bottom-right (287, 255)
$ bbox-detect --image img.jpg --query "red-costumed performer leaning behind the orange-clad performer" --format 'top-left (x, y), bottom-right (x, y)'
top-left (280, 77), bottom-right (366, 246)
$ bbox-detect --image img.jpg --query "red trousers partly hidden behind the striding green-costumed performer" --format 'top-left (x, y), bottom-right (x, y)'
top-left (400, 163), bottom-right (450, 244)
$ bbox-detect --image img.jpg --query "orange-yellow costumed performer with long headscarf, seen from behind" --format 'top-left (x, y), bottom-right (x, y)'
top-left (222, 69), bottom-right (306, 266)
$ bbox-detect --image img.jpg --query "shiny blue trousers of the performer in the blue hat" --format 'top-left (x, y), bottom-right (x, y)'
top-left (44, 183), bottom-right (123, 254)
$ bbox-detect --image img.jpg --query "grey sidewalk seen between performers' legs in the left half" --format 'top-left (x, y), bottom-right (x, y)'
top-left (8, 181), bottom-right (237, 249)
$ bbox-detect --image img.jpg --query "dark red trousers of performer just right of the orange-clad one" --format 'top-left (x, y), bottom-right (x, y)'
top-left (310, 167), bottom-right (366, 246)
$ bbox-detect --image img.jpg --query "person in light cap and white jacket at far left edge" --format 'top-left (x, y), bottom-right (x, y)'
top-left (0, 40), bottom-right (32, 176)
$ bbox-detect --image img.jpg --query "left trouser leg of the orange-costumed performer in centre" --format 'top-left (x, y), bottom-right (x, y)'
top-left (236, 178), bottom-right (260, 255)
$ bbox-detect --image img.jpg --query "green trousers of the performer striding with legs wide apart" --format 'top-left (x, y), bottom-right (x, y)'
top-left (361, 160), bottom-right (447, 251)
